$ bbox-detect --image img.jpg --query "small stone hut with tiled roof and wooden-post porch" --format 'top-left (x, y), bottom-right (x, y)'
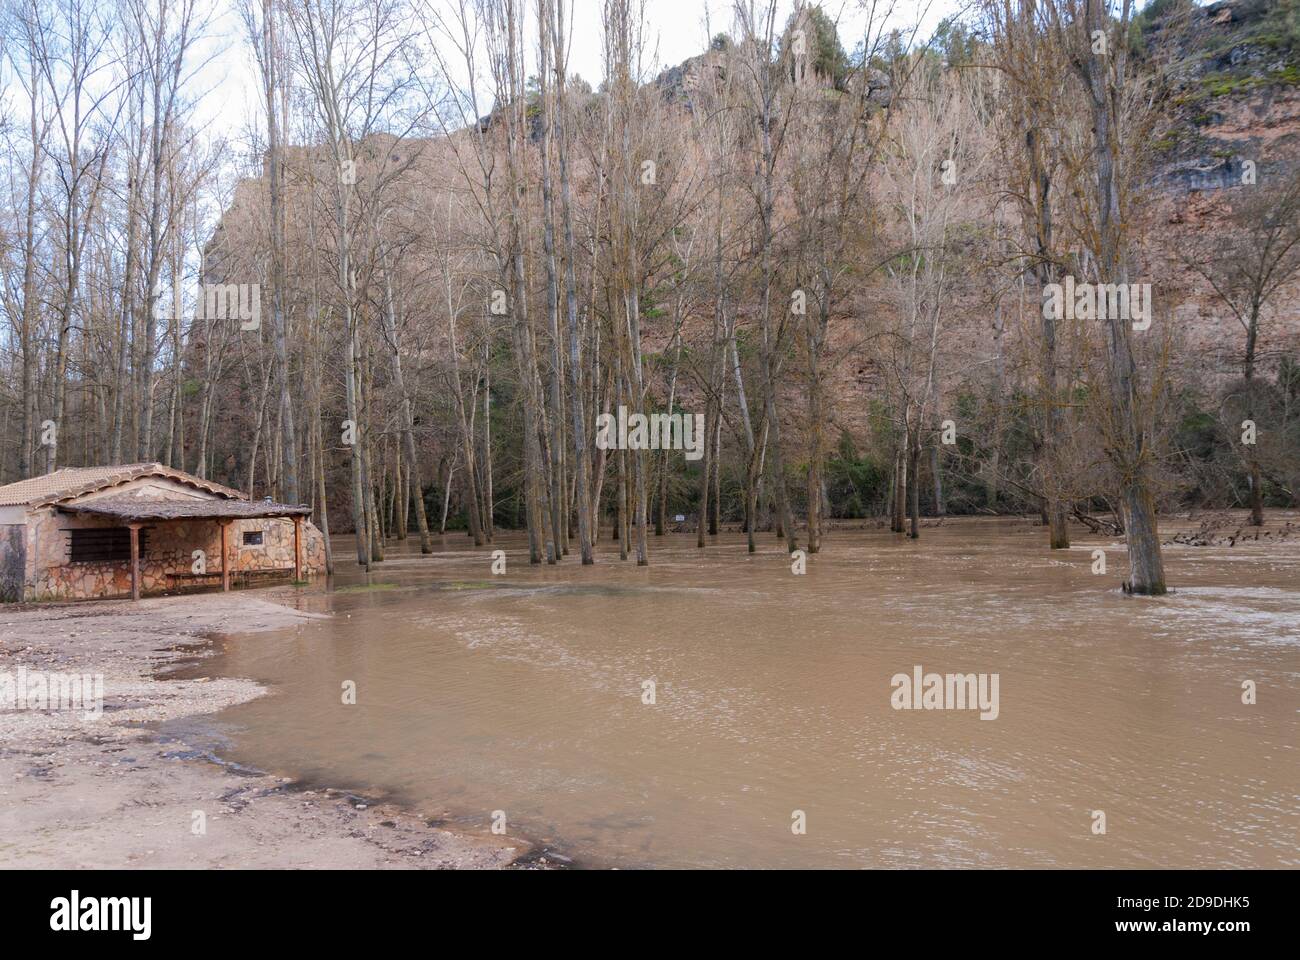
top-left (0, 463), bottom-right (325, 601)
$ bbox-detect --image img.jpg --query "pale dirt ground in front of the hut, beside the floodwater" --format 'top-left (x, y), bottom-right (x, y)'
top-left (0, 593), bottom-right (547, 869)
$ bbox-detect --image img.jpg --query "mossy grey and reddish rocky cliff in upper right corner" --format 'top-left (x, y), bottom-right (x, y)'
top-left (1139, 0), bottom-right (1300, 377)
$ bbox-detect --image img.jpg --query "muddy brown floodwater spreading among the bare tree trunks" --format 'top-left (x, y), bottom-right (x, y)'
top-left (175, 520), bottom-right (1300, 868)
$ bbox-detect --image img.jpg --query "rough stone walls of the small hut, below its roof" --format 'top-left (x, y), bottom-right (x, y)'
top-left (26, 509), bottom-right (325, 600)
